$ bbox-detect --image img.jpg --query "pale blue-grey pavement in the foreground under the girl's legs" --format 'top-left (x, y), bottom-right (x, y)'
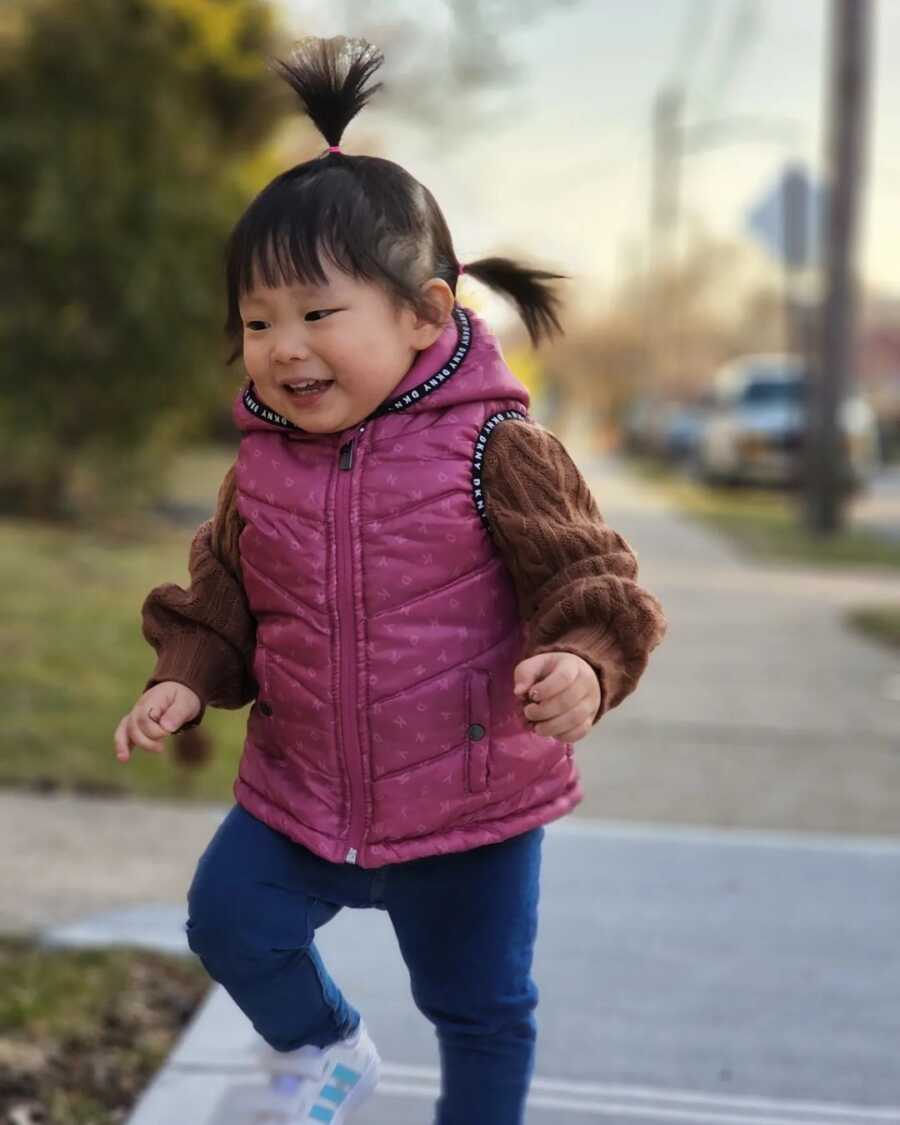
top-left (86, 818), bottom-right (900, 1125)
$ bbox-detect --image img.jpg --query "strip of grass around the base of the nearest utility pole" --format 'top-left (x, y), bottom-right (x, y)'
top-left (628, 457), bottom-right (900, 568)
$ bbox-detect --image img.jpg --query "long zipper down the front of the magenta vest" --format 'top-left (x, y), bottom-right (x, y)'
top-left (335, 425), bottom-right (366, 863)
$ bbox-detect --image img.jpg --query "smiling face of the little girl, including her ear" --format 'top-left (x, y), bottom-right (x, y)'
top-left (240, 262), bottom-right (453, 433)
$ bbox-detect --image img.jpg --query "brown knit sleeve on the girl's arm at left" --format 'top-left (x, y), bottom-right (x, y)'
top-left (141, 466), bottom-right (258, 730)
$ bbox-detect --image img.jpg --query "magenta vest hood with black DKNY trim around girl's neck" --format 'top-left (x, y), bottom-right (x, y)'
top-left (232, 305), bottom-right (531, 443)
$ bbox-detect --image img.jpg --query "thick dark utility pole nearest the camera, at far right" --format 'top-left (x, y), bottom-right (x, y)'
top-left (804, 0), bottom-right (872, 536)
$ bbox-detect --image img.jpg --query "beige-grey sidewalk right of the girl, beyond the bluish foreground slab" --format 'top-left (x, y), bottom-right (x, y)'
top-left (577, 459), bottom-right (900, 834)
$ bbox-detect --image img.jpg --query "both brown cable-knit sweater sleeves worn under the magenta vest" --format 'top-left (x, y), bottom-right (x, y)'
top-left (142, 422), bottom-right (666, 730)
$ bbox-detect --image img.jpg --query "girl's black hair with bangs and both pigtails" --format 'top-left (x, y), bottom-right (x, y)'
top-left (225, 36), bottom-right (565, 363)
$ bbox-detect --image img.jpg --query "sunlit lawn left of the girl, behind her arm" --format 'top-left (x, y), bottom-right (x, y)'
top-left (0, 451), bottom-right (246, 801)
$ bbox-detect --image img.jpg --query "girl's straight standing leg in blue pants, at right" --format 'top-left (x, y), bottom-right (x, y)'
top-left (384, 827), bottom-right (545, 1125)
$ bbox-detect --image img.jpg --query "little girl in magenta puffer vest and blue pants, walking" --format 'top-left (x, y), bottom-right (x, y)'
top-left (115, 37), bottom-right (666, 1125)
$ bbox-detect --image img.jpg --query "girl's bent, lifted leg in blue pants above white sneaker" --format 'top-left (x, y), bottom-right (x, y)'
top-left (187, 806), bottom-right (359, 1051)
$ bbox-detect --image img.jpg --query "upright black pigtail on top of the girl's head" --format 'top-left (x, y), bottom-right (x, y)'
top-left (272, 35), bottom-right (385, 153)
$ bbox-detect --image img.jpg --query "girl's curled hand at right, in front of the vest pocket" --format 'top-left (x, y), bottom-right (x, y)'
top-left (513, 653), bottom-right (602, 743)
